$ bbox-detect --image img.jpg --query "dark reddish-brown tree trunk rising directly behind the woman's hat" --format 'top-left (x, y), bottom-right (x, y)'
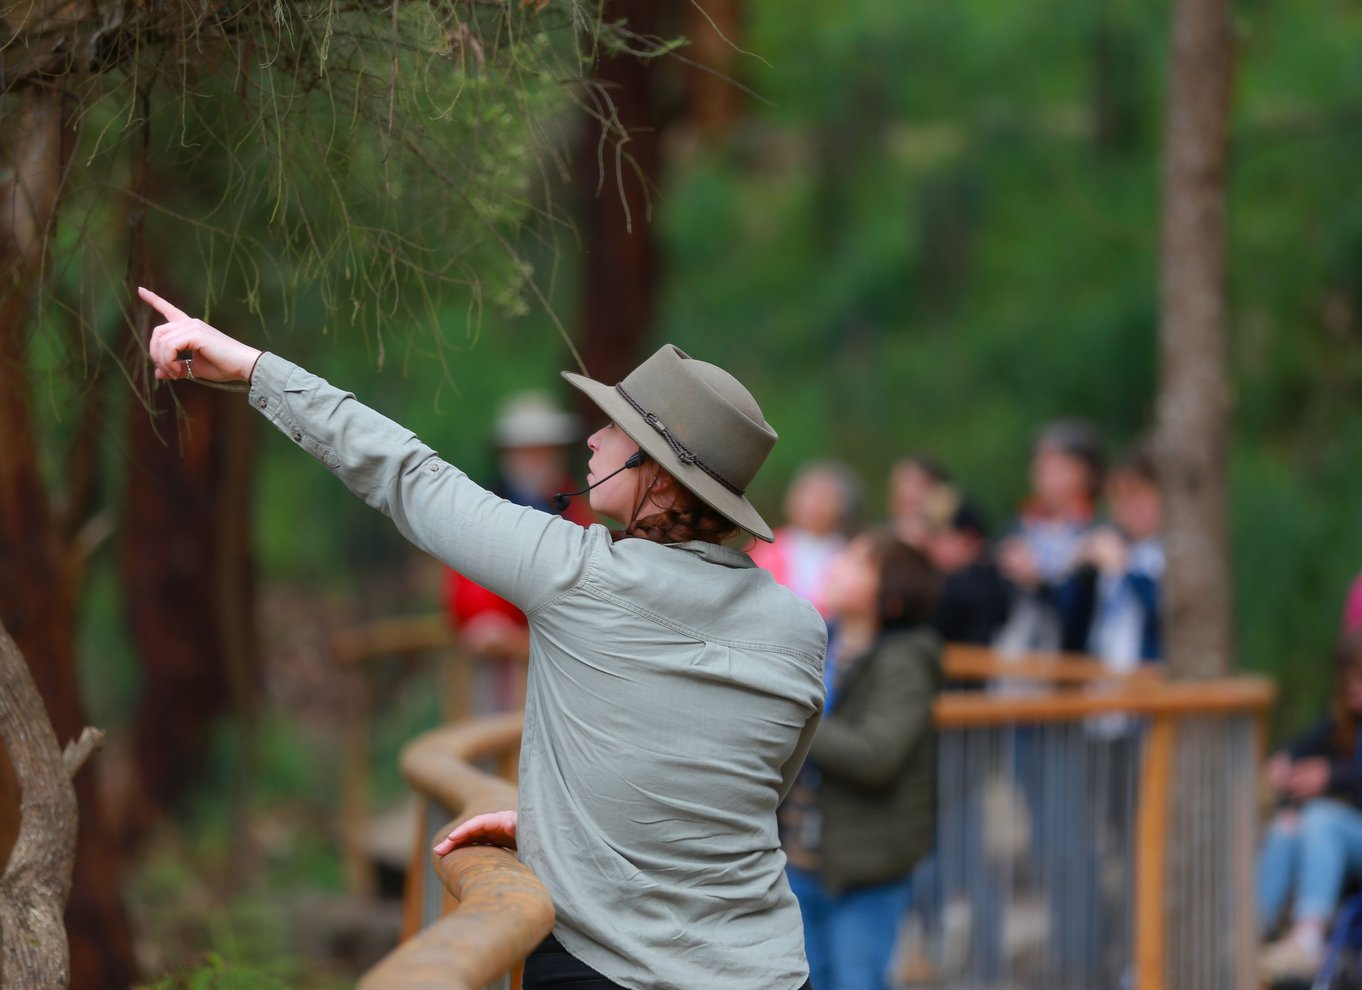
top-left (575, 0), bottom-right (661, 392)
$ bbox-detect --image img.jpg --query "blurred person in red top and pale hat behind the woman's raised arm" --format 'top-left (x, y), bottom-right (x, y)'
top-left (444, 392), bottom-right (595, 669)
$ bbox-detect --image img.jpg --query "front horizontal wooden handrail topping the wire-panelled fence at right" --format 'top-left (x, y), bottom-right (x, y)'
top-left (934, 677), bottom-right (1276, 729)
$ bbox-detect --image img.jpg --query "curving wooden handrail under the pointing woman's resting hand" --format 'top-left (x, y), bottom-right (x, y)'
top-left (360, 712), bottom-right (554, 990)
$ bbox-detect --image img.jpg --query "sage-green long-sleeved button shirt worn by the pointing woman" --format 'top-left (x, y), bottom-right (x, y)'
top-left (251, 354), bottom-right (827, 990)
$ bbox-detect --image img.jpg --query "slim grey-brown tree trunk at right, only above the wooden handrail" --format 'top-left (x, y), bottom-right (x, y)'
top-left (1158, 0), bottom-right (1234, 678)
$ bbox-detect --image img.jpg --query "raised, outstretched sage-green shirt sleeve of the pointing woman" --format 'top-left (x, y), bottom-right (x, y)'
top-left (249, 354), bottom-right (605, 613)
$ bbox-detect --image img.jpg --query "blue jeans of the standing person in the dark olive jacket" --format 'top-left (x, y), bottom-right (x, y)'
top-left (786, 866), bottom-right (913, 990)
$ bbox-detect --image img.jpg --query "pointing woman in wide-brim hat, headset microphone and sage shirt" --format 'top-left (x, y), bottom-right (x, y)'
top-left (142, 290), bottom-right (827, 990)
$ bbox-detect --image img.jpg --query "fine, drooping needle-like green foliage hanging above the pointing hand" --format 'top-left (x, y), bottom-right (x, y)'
top-left (22, 0), bottom-right (601, 403)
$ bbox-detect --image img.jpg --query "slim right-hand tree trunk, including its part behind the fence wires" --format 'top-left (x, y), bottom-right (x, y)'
top-left (1158, 0), bottom-right (1254, 990)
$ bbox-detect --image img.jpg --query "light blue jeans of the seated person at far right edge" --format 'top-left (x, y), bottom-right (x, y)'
top-left (1258, 798), bottom-right (1362, 931)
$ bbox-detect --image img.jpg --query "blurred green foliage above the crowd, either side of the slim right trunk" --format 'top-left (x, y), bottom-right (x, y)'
top-left (640, 0), bottom-right (1362, 729)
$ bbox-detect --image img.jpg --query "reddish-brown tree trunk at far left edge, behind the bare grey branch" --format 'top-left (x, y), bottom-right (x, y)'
top-left (0, 87), bottom-right (136, 990)
